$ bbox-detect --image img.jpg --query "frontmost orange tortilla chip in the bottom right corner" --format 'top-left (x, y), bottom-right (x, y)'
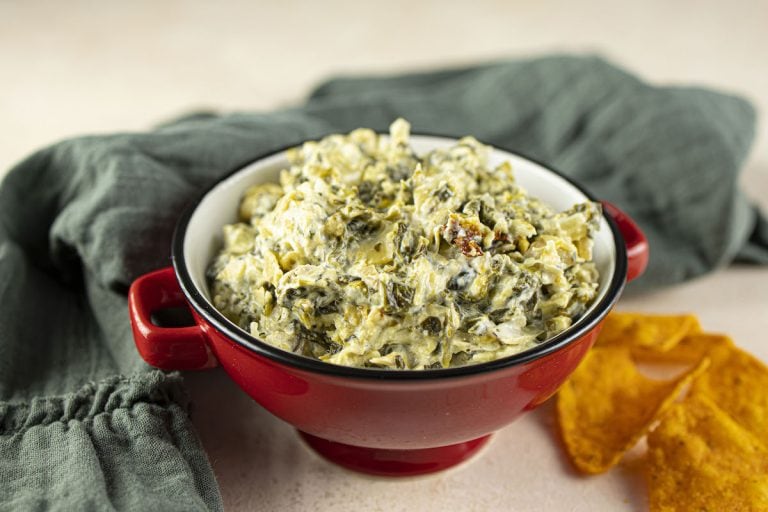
top-left (647, 395), bottom-right (768, 512)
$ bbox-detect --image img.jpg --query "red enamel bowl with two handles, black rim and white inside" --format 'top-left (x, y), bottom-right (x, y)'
top-left (128, 136), bottom-right (648, 476)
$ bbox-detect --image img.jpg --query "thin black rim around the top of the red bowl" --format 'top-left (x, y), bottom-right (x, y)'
top-left (171, 132), bottom-right (627, 381)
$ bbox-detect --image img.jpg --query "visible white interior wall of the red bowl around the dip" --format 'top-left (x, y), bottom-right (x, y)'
top-left (183, 135), bottom-right (616, 334)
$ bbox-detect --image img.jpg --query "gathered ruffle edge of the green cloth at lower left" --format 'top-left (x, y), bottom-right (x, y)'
top-left (0, 371), bottom-right (220, 512)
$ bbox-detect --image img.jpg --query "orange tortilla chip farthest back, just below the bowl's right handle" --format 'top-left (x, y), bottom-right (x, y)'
top-left (595, 312), bottom-right (701, 352)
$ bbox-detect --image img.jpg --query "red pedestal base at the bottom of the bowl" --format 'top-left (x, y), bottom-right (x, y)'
top-left (298, 430), bottom-right (491, 476)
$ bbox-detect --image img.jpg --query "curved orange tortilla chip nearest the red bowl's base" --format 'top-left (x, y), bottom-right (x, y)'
top-left (557, 344), bottom-right (708, 473)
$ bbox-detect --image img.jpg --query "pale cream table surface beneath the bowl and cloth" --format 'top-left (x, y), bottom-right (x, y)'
top-left (0, 0), bottom-right (768, 512)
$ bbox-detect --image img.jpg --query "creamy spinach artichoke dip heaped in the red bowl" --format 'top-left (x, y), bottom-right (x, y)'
top-left (208, 119), bottom-right (601, 369)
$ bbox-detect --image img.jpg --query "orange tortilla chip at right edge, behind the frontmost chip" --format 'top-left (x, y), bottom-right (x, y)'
top-left (690, 340), bottom-right (768, 447)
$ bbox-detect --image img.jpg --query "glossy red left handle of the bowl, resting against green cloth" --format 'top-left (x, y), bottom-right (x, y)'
top-left (128, 267), bottom-right (217, 370)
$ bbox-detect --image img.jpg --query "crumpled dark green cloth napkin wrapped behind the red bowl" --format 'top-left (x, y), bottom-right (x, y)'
top-left (0, 56), bottom-right (768, 511)
